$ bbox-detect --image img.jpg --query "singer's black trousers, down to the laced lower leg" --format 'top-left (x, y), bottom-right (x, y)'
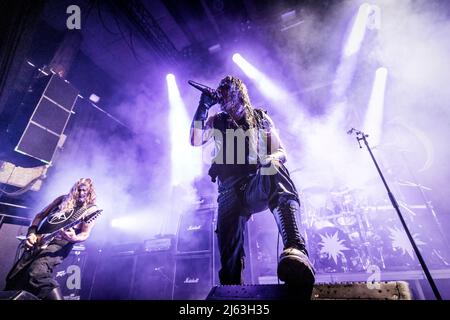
top-left (216, 165), bottom-right (306, 284)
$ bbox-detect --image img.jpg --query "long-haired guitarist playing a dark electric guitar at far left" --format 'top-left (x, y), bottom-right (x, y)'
top-left (5, 178), bottom-right (98, 300)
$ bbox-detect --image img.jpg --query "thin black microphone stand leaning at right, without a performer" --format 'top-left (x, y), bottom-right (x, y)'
top-left (347, 128), bottom-right (442, 300)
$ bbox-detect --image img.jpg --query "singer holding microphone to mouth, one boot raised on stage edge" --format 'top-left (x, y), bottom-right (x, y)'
top-left (190, 76), bottom-right (315, 290)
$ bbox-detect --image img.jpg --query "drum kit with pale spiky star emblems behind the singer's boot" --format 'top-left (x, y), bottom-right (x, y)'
top-left (301, 187), bottom-right (449, 273)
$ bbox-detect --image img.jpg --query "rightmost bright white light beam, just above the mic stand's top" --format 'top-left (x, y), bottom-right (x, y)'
top-left (364, 68), bottom-right (388, 146)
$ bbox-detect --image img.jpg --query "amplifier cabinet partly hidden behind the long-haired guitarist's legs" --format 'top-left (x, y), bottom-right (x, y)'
top-left (53, 245), bottom-right (86, 300)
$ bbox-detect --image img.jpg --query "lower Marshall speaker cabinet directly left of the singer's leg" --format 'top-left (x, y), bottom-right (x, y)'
top-left (172, 254), bottom-right (214, 300)
